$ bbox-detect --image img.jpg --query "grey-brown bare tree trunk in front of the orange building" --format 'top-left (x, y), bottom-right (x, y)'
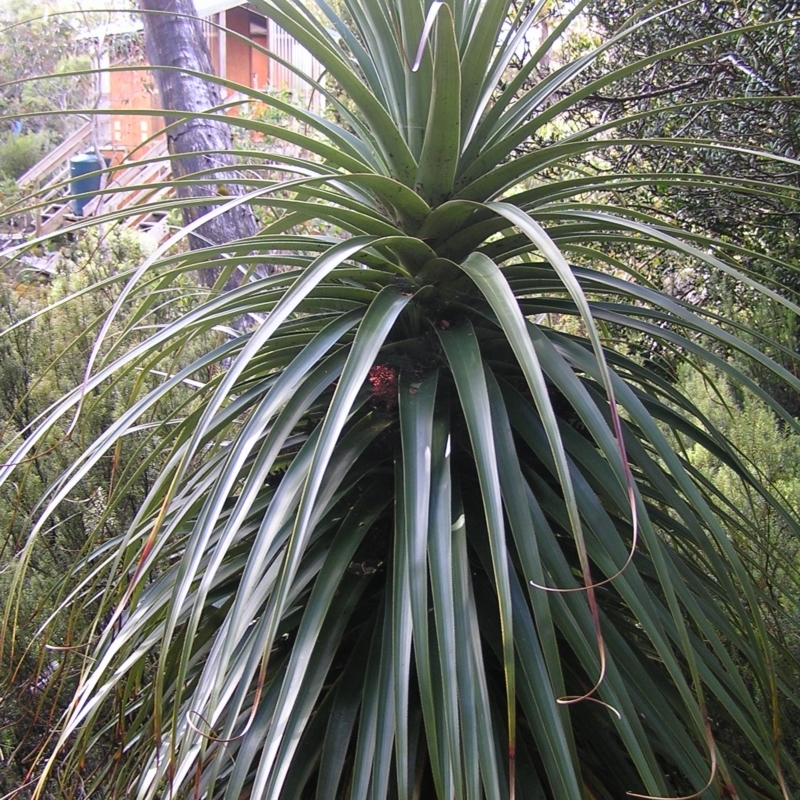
top-left (139, 0), bottom-right (257, 288)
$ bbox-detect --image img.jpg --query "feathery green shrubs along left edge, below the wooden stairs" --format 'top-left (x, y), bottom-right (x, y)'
top-left (0, 229), bottom-right (212, 798)
